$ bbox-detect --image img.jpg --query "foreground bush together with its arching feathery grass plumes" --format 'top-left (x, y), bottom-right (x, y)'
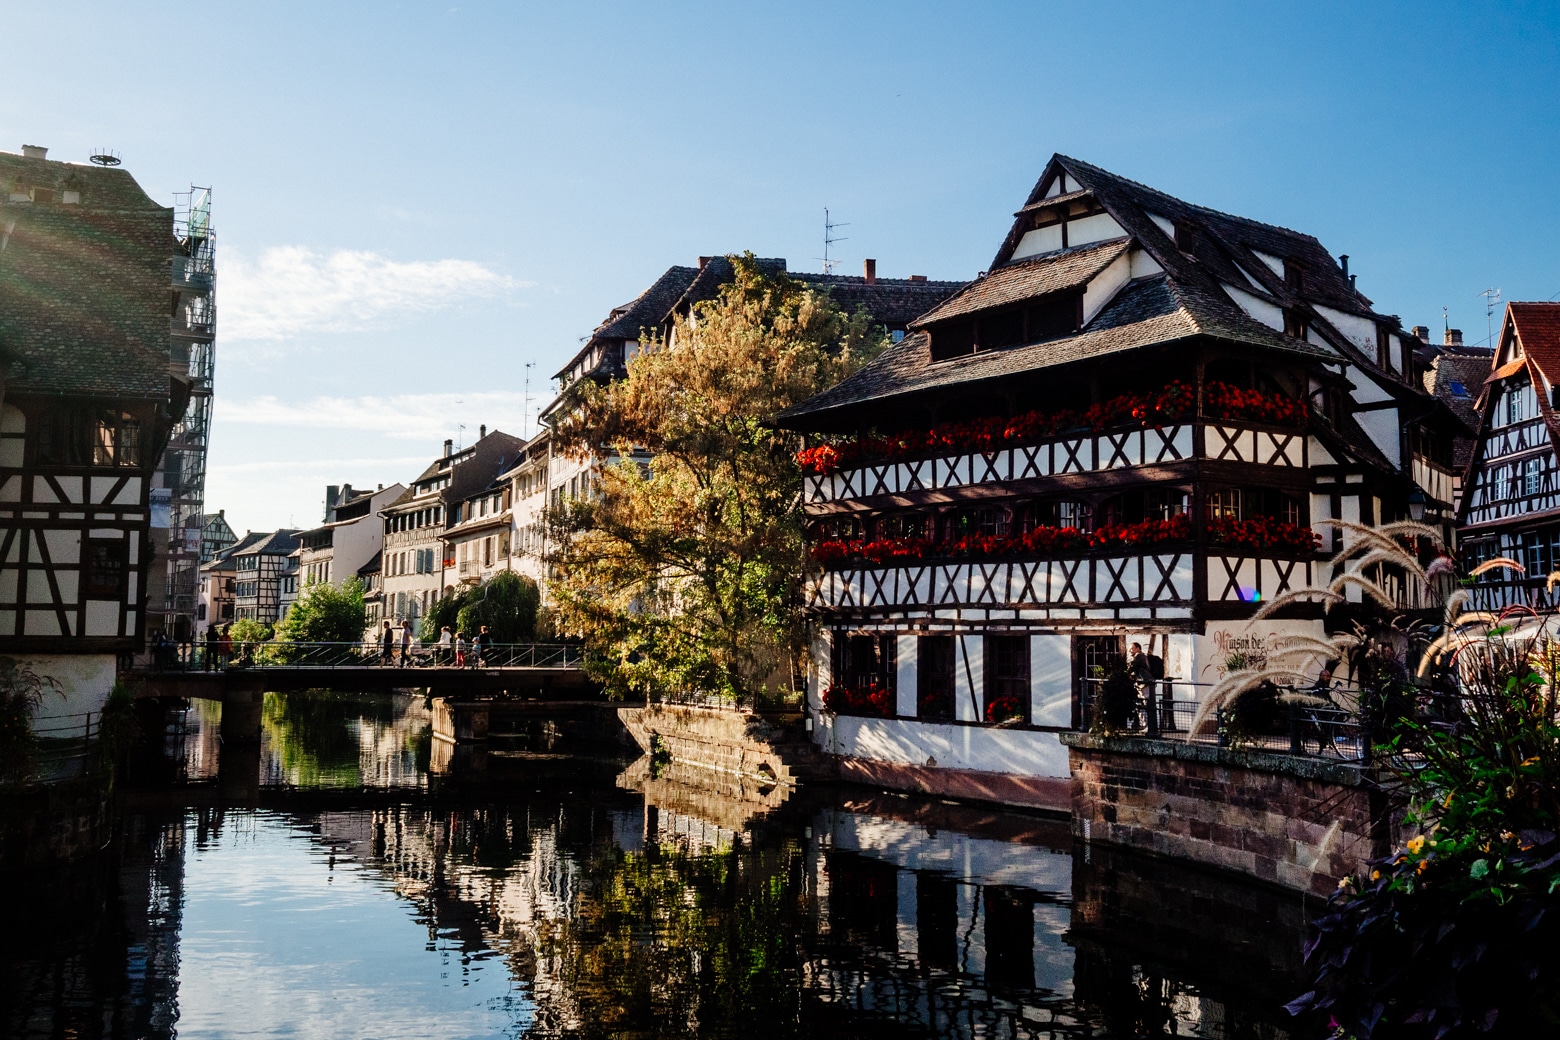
top-left (1211, 524), bottom-right (1560, 1040)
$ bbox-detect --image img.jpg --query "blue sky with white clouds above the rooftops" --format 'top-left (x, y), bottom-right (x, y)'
top-left (0, 0), bottom-right (1560, 532)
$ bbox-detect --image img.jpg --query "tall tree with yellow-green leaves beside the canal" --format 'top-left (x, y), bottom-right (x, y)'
top-left (549, 254), bottom-right (885, 699)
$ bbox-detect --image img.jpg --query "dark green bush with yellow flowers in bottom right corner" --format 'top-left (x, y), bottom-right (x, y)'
top-left (1292, 639), bottom-right (1560, 1040)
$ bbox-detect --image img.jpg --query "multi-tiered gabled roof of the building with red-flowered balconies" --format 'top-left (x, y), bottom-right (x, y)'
top-left (780, 154), bottom-right (1435, 429)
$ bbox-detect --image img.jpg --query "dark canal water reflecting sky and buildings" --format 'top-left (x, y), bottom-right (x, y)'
top-left (0, 694), bottom-right (1318, 1040)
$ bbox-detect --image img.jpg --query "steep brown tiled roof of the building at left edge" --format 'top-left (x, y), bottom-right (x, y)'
top-left (0, 153), bottom-right (173, 398)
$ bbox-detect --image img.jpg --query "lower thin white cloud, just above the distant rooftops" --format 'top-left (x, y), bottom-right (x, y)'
top-left (215, 391), bottom-right (544, 443)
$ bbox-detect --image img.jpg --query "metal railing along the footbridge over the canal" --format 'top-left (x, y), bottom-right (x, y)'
top-left (151, 639), bottom-right (583, 672)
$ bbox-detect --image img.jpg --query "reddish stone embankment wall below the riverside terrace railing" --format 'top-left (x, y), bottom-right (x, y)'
top-left (1062, 733), bottom-right (1390, 895)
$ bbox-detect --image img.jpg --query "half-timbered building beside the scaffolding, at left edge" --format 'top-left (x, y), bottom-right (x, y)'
top-left (0, 147), bottom-right (189, 711)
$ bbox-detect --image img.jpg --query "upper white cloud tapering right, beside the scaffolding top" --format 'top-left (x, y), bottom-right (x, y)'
top-left (218, 246), bottom-right (529, 343)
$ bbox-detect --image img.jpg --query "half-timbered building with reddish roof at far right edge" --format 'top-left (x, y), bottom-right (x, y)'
top-left (1459, 302), bottom-right (1560, 610)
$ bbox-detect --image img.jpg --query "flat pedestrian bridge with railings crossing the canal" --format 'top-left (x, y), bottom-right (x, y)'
top-left (129, 641), bottom-right (594, 702)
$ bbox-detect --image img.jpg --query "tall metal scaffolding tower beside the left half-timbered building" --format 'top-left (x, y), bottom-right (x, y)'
top-left (151, 186), bottom-right (217, 638)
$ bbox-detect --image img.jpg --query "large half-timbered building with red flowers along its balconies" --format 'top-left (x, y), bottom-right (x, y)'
top-left (780, 156), bottom-right (1460, 803)
